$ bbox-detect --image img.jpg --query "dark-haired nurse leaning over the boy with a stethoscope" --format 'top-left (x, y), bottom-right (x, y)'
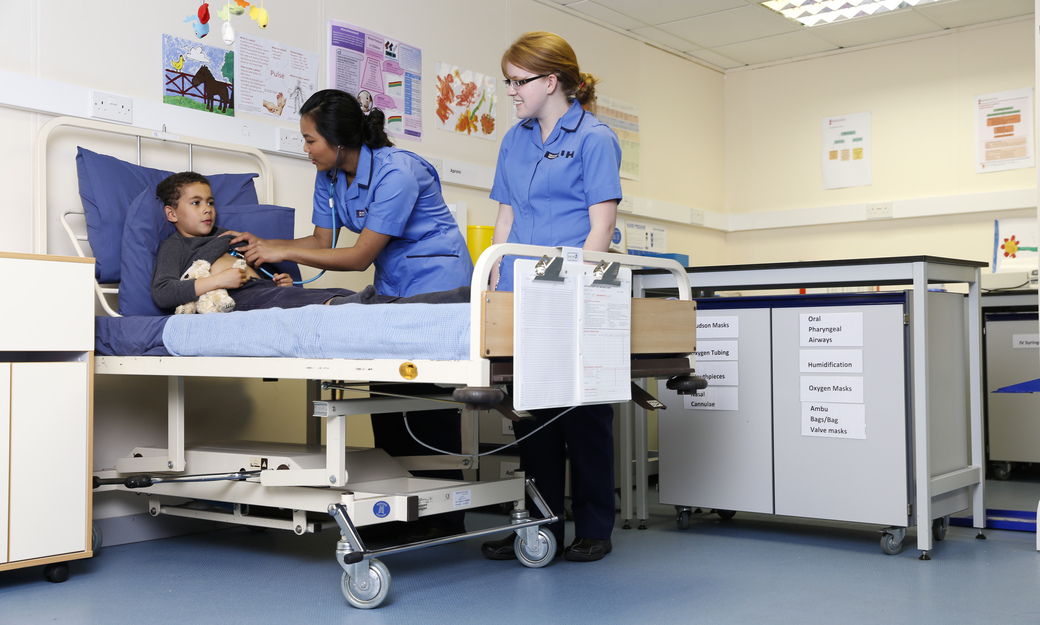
top-left (232, 89), bottom-right (473, 296)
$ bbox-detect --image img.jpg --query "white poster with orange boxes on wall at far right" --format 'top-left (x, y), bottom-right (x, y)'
top-left (976, 87), bottom-right (1036, 174)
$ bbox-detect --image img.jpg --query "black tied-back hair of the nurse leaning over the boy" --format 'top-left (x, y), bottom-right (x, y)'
top-left (300, 89), bottom-right (393, 150)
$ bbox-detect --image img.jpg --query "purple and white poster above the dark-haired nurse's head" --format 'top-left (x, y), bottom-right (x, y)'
top-left (329, 20), bottom-right (422, 140)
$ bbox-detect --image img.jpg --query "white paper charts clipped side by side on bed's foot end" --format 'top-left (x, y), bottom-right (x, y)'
top-left (513, 253), bottom-right (632, 410)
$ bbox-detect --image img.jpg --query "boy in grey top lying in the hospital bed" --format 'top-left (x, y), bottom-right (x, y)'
top-left (152, 172), bottom-right (384, 310)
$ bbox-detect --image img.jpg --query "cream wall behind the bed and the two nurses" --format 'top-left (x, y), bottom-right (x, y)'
top-left (0, 0), bottom-right (725, 540)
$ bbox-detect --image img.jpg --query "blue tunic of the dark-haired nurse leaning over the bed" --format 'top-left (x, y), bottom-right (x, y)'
top-left (311, 146), bottom-right (473, 296)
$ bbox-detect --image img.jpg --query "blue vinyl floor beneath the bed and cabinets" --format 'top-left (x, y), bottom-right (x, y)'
top-left (0, 486), bottom-right (1040, 625)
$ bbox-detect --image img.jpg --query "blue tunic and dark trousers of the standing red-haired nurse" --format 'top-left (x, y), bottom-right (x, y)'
top-left (491, 101), bottom-right (621, 545)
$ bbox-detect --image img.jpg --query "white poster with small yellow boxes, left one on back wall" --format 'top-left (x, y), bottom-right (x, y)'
top-left (823, 113), bottom-right (873, 189)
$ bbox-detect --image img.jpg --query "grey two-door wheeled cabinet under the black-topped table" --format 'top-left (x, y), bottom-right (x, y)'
top-left (658, 292), bottom-right (969, 552)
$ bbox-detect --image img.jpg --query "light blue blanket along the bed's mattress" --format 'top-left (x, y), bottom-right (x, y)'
top-left (162, 304), bottom-right (470, 360)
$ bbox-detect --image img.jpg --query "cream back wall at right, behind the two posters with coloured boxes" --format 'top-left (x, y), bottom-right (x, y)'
top-left (725, 18), bottom-right (1036, 263)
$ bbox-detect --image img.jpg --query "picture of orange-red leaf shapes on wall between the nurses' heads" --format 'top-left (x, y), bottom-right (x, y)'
top-left (437, 61), bottom-right (496, 140)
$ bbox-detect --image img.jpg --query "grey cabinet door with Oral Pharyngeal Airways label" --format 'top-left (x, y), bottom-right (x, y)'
top-left (773, 304), bottom-right (909, 526)
